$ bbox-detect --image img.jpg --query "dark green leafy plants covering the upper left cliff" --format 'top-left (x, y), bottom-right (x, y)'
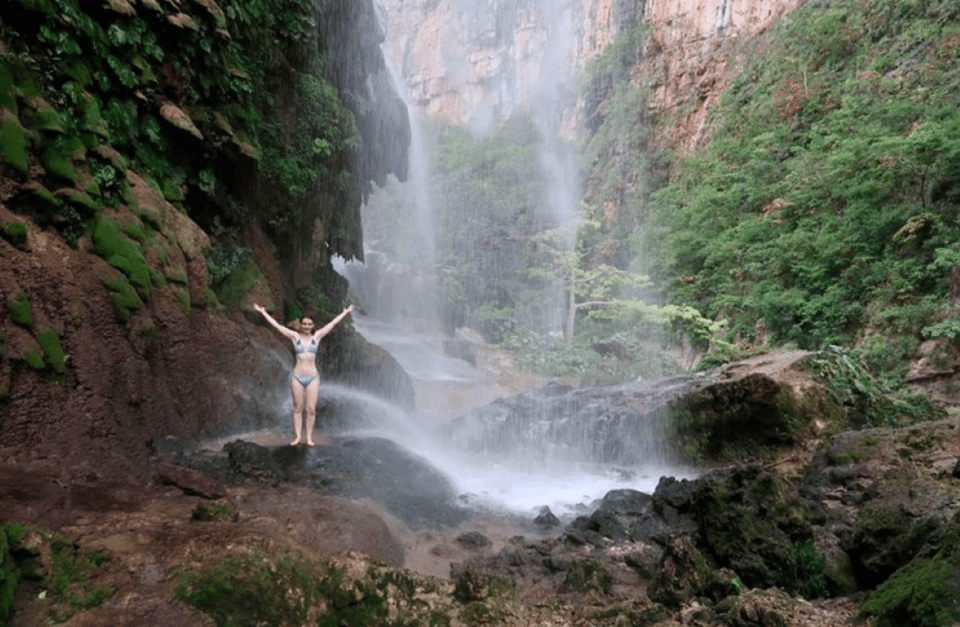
top-left (0, 0), bottom-right (390, 318)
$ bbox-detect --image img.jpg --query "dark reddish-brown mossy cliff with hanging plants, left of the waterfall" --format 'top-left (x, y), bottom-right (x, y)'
top-left (0, 0), bottom-right (412, 481)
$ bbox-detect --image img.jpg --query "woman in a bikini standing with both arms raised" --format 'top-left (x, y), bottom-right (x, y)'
top-left (253, 304), bottom-right (353, 446)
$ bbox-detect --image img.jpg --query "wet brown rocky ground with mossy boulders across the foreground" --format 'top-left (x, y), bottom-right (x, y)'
top-left (0, 355), bottom-right (960, 627)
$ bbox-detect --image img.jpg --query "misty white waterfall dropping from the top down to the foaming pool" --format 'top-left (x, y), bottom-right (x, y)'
top-left (332, 0), bottom-right (696, 516)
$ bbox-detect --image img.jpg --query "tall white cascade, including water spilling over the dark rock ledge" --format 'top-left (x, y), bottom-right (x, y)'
top-left (318, 0), bottom-right (696, 517)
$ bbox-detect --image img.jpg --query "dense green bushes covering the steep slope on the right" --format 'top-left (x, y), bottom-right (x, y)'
top-left (634, 0), bottom-right (960, 370)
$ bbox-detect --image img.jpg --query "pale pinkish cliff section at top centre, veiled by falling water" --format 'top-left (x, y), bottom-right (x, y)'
top-left (383, 0), bottom-right (620, 135)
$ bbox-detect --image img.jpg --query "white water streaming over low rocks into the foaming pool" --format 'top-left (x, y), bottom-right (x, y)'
top-left (344, 316), bottom-right (689, 519)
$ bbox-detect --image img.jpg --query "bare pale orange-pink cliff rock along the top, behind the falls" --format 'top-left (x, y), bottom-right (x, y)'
top-left (383, 0), bottom-right (801, 150)
